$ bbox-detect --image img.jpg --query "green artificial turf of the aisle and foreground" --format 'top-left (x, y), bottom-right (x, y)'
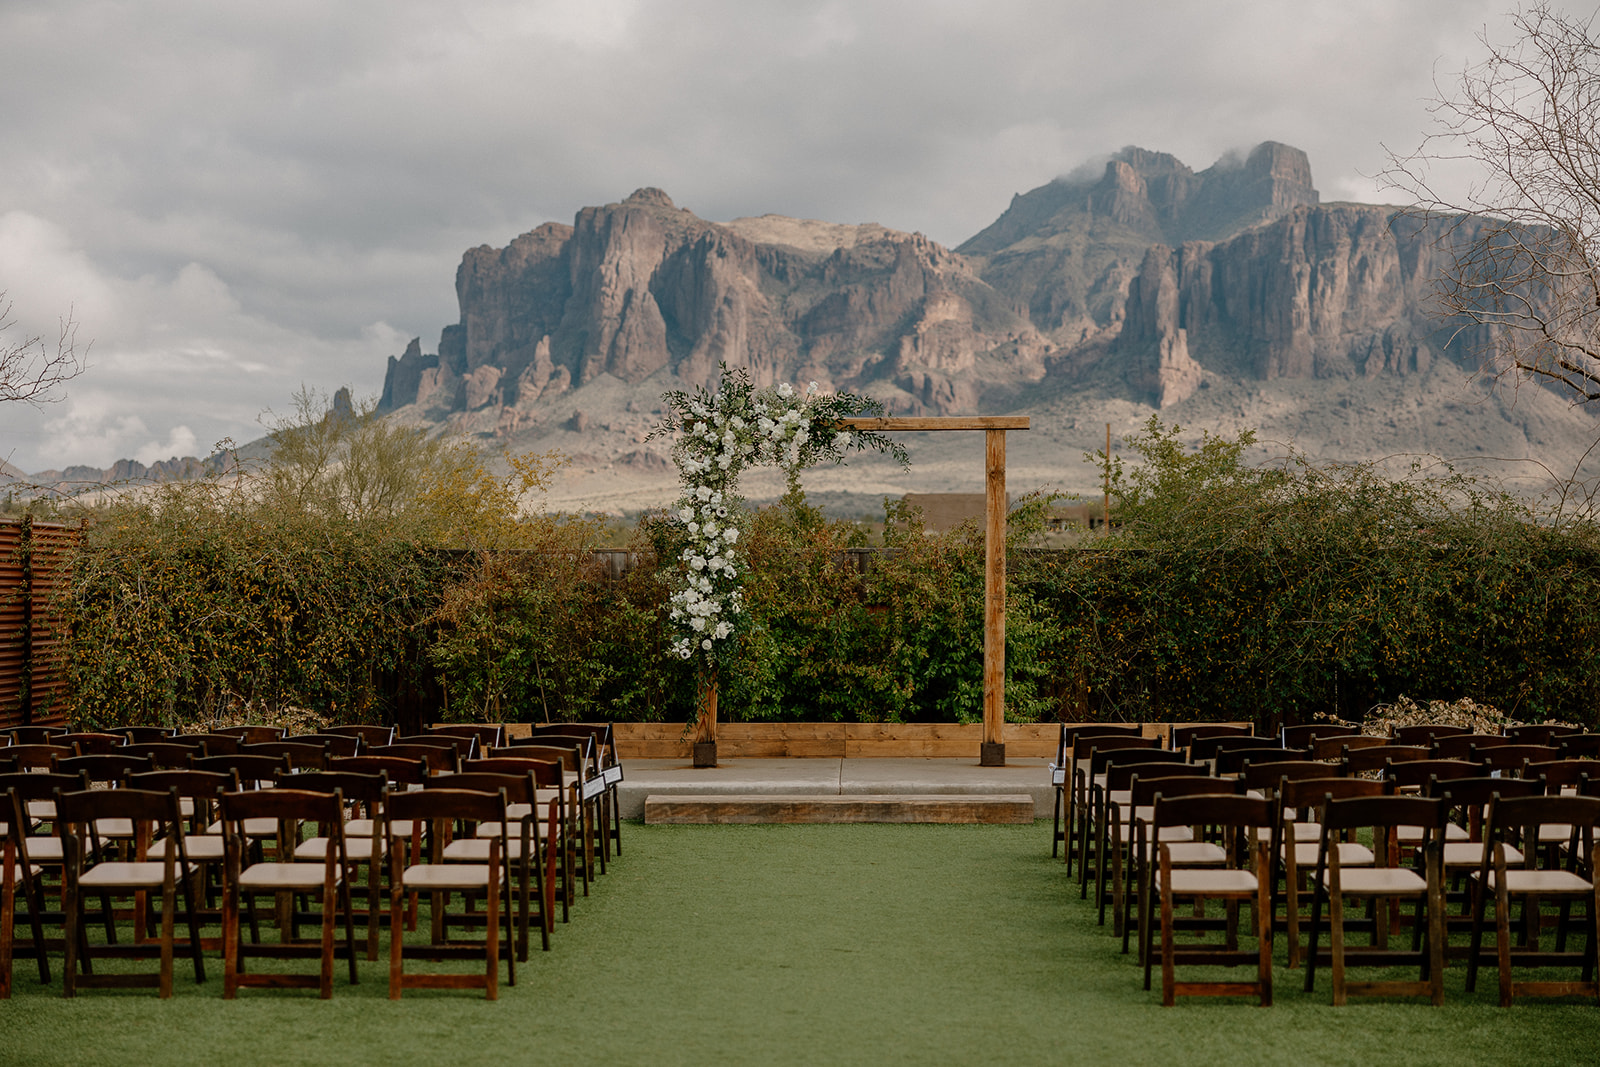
top-left (0, 825), bottom-right (1600, 1067)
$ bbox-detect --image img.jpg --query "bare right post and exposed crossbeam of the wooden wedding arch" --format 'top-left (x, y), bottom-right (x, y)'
top-left (840, 414), bottom-right (1027, 766)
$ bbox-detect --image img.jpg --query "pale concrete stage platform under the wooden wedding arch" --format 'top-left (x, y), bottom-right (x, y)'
top-left (618, 757), bottom-right (1054, 819)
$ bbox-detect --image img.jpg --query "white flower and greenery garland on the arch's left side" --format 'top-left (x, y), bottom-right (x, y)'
top-left (651, 366), bottom-right (906, 673)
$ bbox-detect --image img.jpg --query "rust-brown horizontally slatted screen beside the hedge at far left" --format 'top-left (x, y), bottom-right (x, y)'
top-left (0, 517), bottom-right (78, 728)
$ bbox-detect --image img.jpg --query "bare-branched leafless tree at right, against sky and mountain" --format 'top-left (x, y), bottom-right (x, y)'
top-left (1382, 2), bottom-right (1600, 403)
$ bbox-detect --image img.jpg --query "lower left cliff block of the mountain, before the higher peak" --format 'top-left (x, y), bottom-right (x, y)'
top-left (381, 189), bottom-right (1051, 430)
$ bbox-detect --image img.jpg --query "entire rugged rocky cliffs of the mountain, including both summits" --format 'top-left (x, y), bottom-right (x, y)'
top-left (381, 142), bottom-right (1482, 461)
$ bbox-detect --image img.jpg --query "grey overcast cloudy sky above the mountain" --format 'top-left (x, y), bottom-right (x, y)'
top-left (0, 0), bottom-right (1509, 470)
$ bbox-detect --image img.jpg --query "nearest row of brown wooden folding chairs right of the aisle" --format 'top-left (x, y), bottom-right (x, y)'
top-left (1094, 765), bottom-right (1600, 1005)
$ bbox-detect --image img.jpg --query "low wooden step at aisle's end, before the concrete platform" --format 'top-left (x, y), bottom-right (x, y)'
top-left (645, 793), bottom-right (1034, 825)
